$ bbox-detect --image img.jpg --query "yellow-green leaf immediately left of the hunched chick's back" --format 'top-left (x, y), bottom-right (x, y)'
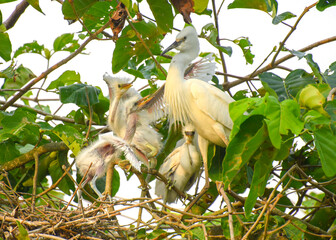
top-left (52, 124), bottom-right (84, 156)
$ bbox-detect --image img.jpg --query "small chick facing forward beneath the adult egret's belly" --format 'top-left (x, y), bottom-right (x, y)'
top-left (155, 124), bottom-right (202, 203)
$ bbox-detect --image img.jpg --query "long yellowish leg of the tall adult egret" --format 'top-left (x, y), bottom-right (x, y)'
top-left (185, 136), bottom-right (210, 212)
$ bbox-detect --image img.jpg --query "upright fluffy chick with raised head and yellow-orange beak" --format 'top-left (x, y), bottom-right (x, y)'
top-left (103, 74), bottom-right (162, 158)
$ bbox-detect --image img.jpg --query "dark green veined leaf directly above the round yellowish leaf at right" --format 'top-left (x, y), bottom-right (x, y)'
top-left (285, 69), bottom-right (315, 97)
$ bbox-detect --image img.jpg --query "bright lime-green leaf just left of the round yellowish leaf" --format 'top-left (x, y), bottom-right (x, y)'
top-left (279, 99), bottom-right (304, 135)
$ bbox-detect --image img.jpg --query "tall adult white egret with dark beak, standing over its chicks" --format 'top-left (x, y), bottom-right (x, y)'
top-left (161, 26), bottom-right (234, 200)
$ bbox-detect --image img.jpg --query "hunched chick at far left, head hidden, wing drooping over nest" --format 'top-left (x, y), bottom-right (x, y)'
top-left (76, 134), bottom-right (141, 198)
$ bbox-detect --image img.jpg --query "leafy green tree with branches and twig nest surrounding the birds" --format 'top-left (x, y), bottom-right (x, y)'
top-left (0, 0), bottom-right (336, 239)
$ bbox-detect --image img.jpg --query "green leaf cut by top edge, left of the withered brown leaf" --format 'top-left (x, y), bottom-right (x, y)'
top-left (62, 0), bottom-right (98, 20)
